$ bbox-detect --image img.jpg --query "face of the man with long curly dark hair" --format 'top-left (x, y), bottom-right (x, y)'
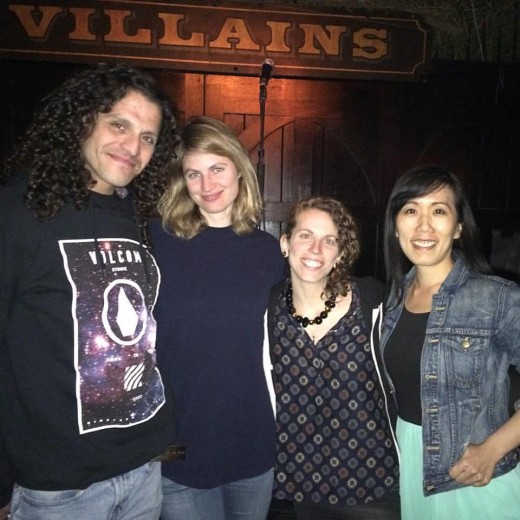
top-left (81, 91), bottom-right (161, 195)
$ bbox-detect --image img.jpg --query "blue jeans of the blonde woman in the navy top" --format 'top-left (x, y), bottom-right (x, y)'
top-left (161, 469), bottom-right (274, 520)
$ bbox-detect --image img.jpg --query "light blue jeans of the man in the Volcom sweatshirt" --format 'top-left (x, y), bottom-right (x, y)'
top-left (10, 462), bottom-right (162, 520)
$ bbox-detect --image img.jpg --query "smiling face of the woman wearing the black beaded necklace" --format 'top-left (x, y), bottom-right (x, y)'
top-left (280, 208), bottom-right (341, 287)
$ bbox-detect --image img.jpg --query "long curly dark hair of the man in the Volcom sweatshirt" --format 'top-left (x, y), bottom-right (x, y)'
top-left (0, 63), bottom-right (178, 226)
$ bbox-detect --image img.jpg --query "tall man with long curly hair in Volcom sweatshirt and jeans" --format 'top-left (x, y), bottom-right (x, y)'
top-left (0, 64), bottom-right (181, 520)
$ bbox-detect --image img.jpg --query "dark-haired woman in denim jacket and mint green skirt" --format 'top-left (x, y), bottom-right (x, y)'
top-left (381, 166), bottom-right (520, 520)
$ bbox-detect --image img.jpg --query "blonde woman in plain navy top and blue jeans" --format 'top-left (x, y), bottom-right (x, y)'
top-left (151, 117), bottom-right (283, 520)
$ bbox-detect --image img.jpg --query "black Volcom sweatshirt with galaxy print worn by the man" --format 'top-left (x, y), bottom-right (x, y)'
top-left (0, 176), bottom-right (175, 505)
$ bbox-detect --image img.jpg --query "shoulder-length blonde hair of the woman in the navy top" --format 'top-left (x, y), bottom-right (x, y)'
top-left (158, 116), bottom-right (262, 238)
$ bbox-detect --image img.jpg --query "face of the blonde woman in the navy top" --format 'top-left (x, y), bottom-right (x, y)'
top-left (182, 148), bottom-right (240, 227)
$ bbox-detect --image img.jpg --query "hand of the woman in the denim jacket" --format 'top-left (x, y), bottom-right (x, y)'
top-left (450, 442), bottom-right (500, 487)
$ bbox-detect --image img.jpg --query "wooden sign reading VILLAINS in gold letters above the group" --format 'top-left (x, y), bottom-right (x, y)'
top-left (0, 0), bottom-right (430, 79)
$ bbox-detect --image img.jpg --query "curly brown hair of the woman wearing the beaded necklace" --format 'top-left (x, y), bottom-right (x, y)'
top-left (285, 197), bottom-right (361, 297)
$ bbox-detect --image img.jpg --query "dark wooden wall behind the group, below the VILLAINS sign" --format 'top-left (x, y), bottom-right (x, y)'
top-left (0, 60), bottom-right (520, 279)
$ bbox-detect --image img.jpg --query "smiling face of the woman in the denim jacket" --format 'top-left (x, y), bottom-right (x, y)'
top-left (395, 186), bottom-right (462, 273)
